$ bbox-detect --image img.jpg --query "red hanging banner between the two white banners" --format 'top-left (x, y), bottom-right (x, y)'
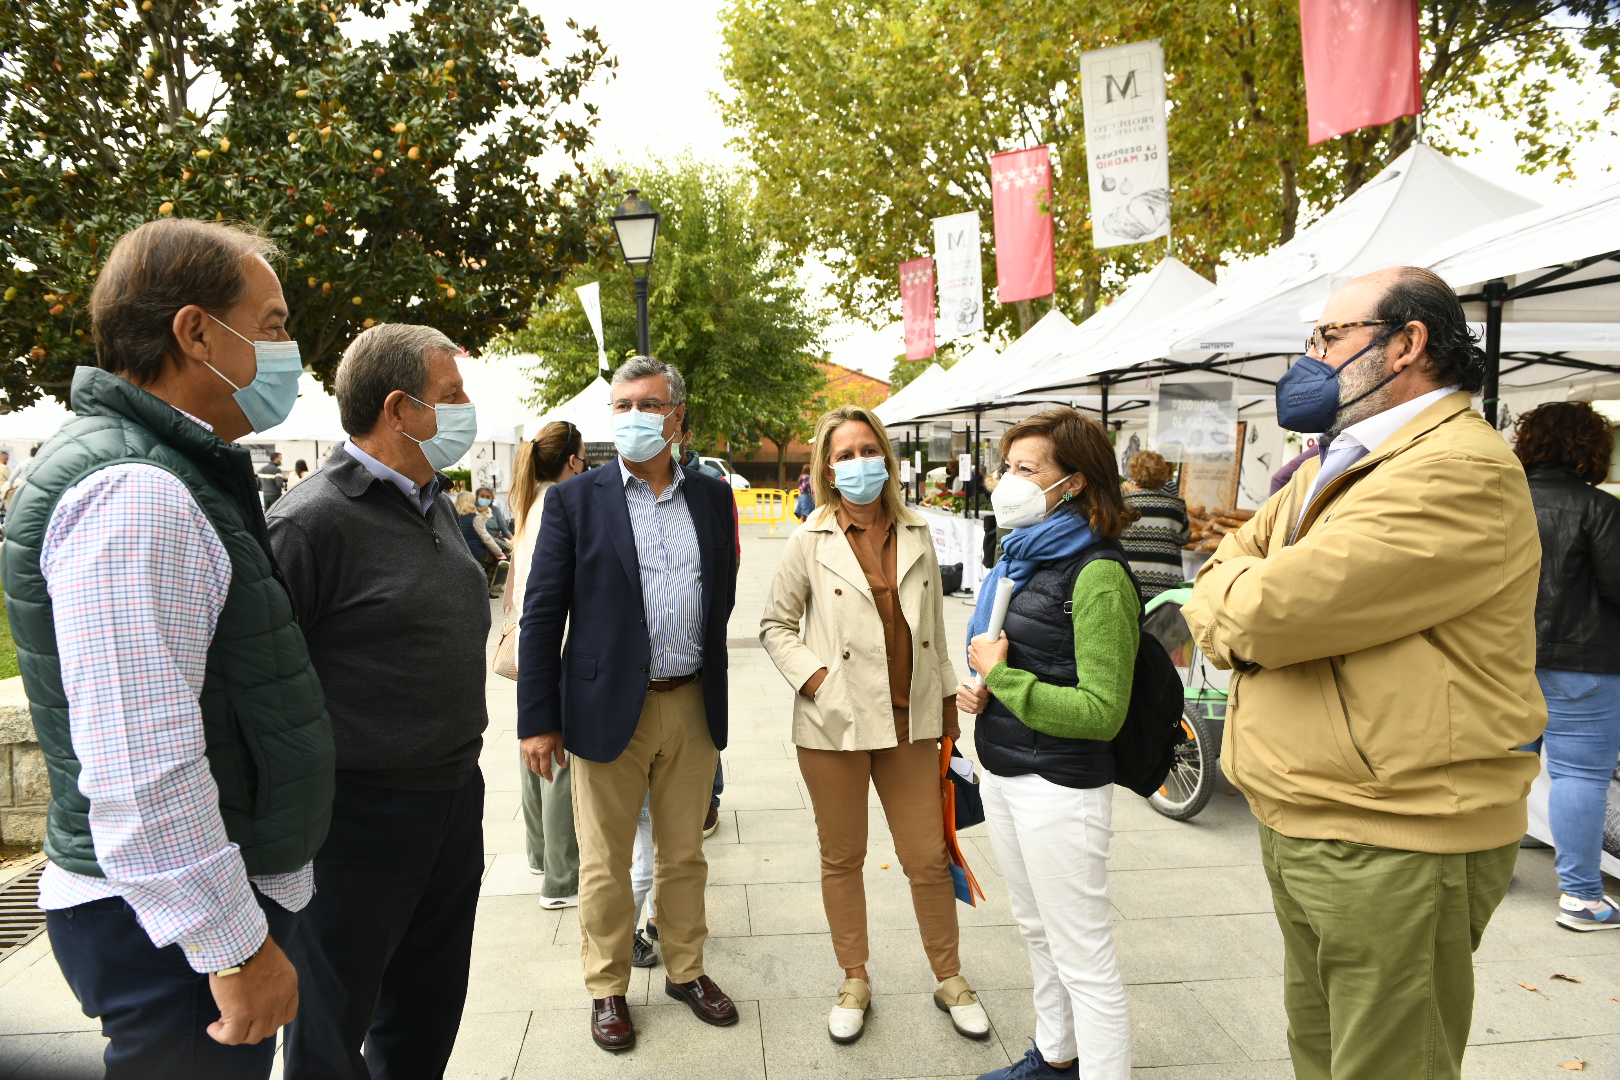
top-left (990, 146), bottom-right (1058, 304)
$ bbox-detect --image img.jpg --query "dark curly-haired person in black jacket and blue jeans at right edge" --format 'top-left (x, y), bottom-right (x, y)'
top-left (1513, 402), bottom-right (1620, 929)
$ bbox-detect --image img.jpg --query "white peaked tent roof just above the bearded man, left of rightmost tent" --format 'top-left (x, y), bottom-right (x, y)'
top-left (1022, 144), bottom-right (1536, 420)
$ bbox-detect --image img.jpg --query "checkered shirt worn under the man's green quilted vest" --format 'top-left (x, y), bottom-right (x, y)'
top-left (39, 465), bottom-right (314, 972)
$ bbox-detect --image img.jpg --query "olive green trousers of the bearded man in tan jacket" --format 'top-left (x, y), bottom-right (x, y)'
top-left (1260, 824), bottom-right (1518, 1080)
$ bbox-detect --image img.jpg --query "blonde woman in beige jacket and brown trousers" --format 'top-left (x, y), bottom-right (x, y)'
top-left (760, 405), bottom-right (990, 1043)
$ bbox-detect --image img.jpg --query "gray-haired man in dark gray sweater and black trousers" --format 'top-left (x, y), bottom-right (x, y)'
top-left (266, 325), bottom-right (489, 1080)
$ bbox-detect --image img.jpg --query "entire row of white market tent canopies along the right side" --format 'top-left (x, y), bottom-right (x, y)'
top-left (880, 144), bottom-right (1620, 426)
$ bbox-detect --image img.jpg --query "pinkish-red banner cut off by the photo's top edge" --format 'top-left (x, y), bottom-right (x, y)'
top-left (1299, 0), bottom-right (1422, 146)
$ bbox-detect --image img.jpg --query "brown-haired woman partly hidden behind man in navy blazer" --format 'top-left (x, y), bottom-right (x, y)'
top-left (502, 421), bottom-right (585, 908)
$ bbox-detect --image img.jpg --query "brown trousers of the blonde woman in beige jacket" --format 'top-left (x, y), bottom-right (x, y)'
top-left (797, 709), bottom-right (962, 981)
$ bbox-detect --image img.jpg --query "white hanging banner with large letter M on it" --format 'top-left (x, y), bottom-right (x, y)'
top-left (1081, 40), bottom-right (1170, 248)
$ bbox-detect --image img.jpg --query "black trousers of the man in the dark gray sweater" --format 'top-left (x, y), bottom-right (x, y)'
top-left (285, 771), bottom-right (484, 1080)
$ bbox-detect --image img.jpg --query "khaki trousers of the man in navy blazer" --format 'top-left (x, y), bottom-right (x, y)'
top-left (569, 678), bottom-right (719, 999)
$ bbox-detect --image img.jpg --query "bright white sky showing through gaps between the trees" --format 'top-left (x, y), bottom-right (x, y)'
top-left (539, 0), bottom-right (1620, 379)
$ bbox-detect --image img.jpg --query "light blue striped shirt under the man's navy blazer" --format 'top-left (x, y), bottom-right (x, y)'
top-left (619, 458), bottom-right (703, 678)
